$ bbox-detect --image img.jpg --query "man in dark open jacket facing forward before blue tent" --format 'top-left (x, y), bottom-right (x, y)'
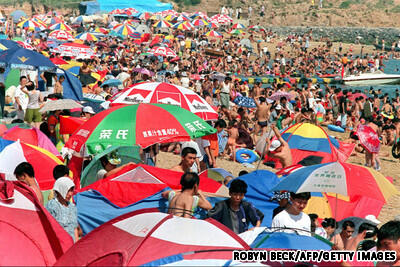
top-left (208, 179), bottom-right (264, 234)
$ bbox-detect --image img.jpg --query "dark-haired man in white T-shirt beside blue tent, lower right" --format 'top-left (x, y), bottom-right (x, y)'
top-left (271, 192), bottom-right (311, 236)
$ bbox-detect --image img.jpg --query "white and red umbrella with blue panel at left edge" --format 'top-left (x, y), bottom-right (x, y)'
top-left (0, 138), bottom-right (63, 190)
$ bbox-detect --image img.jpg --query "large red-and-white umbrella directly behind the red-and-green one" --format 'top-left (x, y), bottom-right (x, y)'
top-left (111, 82), bottom-right (218, 120)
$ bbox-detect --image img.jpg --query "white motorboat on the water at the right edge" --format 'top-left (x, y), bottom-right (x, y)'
top-left (343, 70), bottom-right (400, 86)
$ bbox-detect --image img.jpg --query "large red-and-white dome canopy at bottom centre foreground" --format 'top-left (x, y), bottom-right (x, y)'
top-left (55, 210), bottom-right (249, 266)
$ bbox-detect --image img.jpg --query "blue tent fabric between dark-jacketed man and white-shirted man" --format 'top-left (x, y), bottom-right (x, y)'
top-left (230, 170), bottom-right (280, 227)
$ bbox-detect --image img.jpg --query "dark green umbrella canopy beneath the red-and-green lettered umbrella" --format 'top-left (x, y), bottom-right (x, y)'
top-left (81, 146), bottom-right (142, 188)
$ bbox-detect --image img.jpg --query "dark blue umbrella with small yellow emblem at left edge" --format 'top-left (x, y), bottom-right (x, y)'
top-left (0, 47), bottom-right (57, 71)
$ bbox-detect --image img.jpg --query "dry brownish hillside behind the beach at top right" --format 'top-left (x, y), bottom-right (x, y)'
top-left (182, 0), bottom-right (400, 27)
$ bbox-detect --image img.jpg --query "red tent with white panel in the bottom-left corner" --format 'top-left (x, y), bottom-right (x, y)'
top-left (0, 178), bottom-right (73, 266)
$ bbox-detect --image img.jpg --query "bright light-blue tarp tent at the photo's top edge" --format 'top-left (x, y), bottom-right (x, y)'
top-left (97, 0), bottom-right (173, 13)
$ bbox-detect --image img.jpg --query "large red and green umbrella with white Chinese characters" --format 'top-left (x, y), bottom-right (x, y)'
top-left (65, 104), bottom-right (215, 154)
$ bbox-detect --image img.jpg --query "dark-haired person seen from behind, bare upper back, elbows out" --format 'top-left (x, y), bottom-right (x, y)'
top-left (162, 172), bottom-right (212, 218)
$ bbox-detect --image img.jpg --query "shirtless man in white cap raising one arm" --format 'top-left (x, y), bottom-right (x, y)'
top-left (267, 125), bottom-right (293, 168)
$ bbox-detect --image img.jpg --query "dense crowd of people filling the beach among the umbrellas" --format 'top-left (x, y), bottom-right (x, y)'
top-left (0, 6), bottom-right (400, 266)
